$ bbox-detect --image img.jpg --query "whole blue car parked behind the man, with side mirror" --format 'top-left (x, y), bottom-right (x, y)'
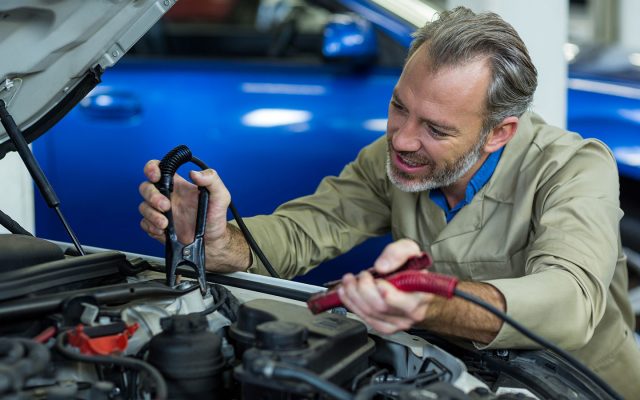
top-left (33, 0), bottom-right (640, 283)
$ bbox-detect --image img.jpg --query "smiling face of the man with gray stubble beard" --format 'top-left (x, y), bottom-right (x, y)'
top-left (387, 45), bottom-right (490, 192)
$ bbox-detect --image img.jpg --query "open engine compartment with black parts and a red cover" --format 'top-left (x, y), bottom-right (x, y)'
top-left (0, 242), bottom-right (606, 400)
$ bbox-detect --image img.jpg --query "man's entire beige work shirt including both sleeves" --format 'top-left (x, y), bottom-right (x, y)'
top-left (236, 113), bottom-right (640, 398)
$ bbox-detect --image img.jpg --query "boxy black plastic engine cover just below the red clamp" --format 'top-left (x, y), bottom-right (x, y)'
top-left (229, 300), bottom-right (375, 399)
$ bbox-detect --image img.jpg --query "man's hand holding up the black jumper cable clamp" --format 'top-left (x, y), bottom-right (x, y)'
top-left (138, 160), bottom-right (250, 272)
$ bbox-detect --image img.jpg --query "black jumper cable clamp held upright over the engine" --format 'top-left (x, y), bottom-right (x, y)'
top-left (156, 145), bottom-right (209, 295)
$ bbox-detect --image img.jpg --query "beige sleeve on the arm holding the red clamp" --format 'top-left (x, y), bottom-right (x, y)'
top-left (476, 141), bottom-right (622, 350)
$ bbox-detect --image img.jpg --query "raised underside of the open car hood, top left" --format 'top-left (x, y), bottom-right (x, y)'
top-left (0, 0), bottom-right (175, 158)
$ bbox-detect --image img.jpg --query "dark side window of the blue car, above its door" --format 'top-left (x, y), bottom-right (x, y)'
top-left (127, 0), bottom-right (406, 67)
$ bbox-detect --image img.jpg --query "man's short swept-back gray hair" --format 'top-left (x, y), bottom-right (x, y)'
top-left (408, 7), bottom-right (538, 134)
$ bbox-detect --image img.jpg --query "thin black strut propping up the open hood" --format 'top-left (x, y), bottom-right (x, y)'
top-left (0, 100), bottom-right (85, 255)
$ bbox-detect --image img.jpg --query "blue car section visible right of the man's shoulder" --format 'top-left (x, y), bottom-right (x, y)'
top-left (567, 45), bottom-right (640, 256)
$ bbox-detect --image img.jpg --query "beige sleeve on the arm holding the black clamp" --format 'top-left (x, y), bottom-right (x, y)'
top-left (230, 137), bottom-right (390, 278)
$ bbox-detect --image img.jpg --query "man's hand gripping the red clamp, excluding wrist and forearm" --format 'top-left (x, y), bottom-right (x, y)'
top-left (338, 239), bottom-right (435, 334)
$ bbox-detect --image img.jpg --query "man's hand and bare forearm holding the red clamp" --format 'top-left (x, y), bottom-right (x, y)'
top-left (338, 239), bottom-right (506, 343)
